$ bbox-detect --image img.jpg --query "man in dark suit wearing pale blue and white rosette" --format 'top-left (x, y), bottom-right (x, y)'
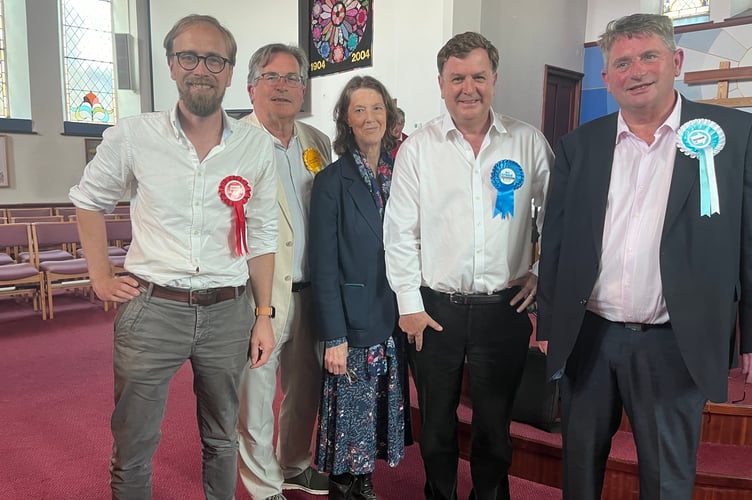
top-left (538, 14), bottom-right (752, 500)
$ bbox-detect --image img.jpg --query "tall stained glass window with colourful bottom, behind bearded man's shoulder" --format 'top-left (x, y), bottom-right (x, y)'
top-left (60, 0), bottom-right (117, 125)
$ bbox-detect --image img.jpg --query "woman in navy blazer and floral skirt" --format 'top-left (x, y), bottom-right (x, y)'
top-left (308, 76), bottom-right (404, 499)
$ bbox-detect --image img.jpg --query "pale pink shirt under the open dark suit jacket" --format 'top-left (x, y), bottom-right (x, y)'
top-left (588, 97), bottom-right (681, 323)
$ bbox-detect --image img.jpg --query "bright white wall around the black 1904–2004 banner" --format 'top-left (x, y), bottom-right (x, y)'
top-left (151, 0), bottom-right (450, 143)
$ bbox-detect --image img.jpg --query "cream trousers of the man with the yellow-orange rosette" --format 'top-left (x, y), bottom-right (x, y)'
top-left (238, 287), bottom-right (323, 499)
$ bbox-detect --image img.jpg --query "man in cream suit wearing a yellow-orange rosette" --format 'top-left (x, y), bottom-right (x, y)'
top-left (239, 44), bottom-right (331, 500)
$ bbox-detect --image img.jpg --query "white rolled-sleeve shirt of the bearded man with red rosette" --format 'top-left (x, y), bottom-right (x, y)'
top-left (69, 108), bottom-right (277, 289)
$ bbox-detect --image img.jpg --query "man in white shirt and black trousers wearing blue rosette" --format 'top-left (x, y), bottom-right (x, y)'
top-left (384, 33), bottom-right (553, 500)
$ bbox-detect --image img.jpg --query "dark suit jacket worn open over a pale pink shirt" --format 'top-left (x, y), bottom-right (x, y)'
top-left (538, 100), bottom-right (752, 401)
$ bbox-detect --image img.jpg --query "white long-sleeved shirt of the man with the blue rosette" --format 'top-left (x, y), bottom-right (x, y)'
top-left (384, 111), bottom-right (553, 314)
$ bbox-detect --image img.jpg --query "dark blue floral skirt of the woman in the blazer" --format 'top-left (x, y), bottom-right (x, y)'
top-left (316, 337), bottom-right (405, 474)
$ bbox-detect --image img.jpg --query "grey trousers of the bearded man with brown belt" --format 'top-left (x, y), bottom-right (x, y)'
top-left (110, 290), bottom-right (253, 500)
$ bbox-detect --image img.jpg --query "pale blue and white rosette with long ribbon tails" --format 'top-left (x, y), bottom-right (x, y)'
top-left (676, 118), bottom-right (726, 217)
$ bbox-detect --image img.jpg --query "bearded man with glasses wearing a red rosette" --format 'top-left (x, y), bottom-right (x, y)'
top-left (70, 15), bottom-right (277, 500)
